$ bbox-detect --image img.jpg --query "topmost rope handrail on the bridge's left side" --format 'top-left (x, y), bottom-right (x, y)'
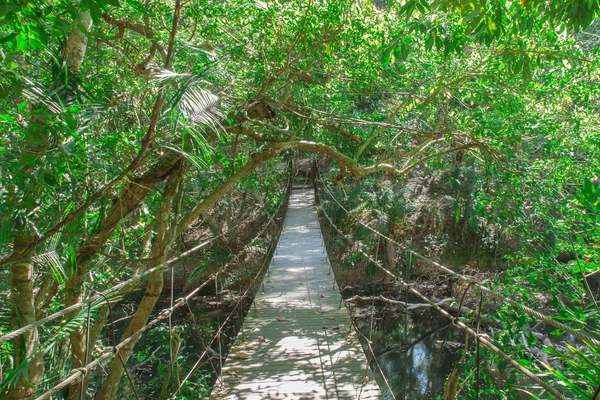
top-left (0, 170), bottom-right (290, 343)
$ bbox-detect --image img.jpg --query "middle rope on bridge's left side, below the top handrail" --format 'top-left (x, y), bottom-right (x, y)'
top-left (36, 168), bottom-right (289, 400)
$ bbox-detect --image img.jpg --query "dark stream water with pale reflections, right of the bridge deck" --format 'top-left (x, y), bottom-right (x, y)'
top-left (359, 310), bottom-right (464, 400)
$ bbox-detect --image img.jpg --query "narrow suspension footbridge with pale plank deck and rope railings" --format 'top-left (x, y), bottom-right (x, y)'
top-left (0, 162), bottom-right (600, 400)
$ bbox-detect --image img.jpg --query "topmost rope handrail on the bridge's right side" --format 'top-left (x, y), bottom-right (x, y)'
top-left (314, 173), bottom-right (600, 347)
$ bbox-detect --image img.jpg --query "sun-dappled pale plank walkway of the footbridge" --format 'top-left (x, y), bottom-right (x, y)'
top-left (211, 188), bottom-right (383, 400)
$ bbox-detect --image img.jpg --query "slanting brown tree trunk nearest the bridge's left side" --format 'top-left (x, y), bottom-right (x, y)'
top-left (98, 162), bottom-right (184, 400)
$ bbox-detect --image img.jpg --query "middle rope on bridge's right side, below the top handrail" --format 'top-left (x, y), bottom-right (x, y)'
top-left (320, 202), bottom-right (568, 400)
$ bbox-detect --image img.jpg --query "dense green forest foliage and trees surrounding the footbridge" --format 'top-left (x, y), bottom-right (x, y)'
top-left (0, 0), bottom-right (600, 399)
